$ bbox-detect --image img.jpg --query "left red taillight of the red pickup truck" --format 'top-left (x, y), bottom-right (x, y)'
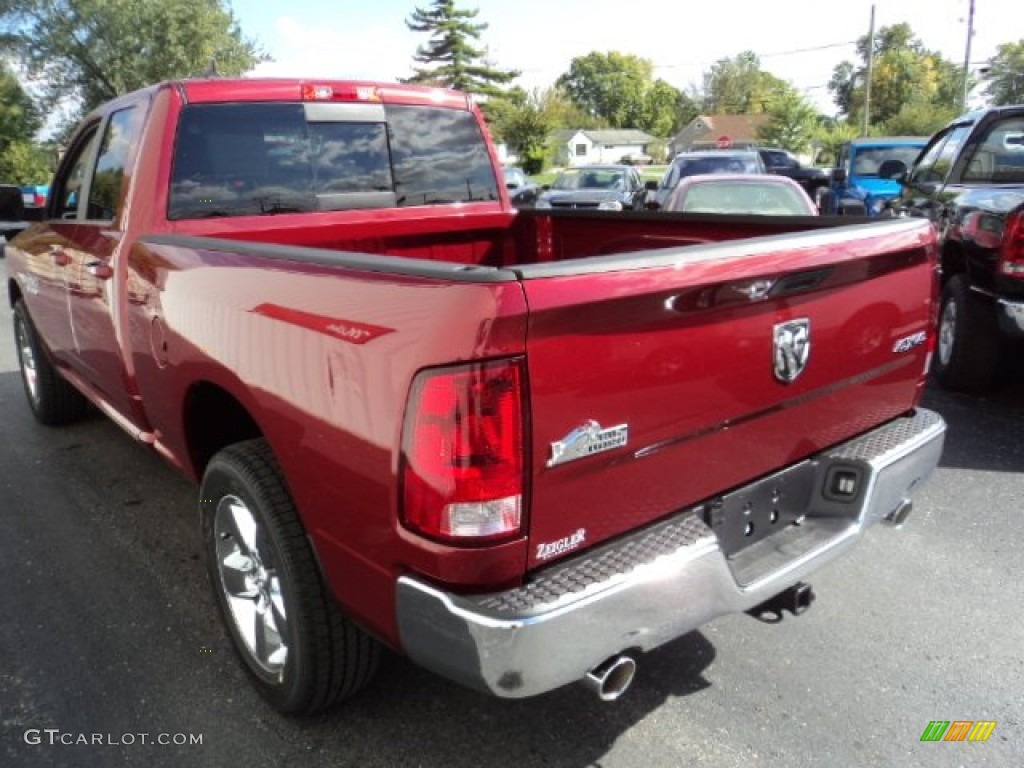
top-left (400, 359), bottom-right (525, 544)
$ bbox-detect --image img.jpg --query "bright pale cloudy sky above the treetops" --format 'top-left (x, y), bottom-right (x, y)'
top-left (229, 0), bottom-right (1024, 114)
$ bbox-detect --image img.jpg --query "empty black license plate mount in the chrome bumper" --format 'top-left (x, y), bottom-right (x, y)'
top-left (705, 461), bottom-right (817, 557)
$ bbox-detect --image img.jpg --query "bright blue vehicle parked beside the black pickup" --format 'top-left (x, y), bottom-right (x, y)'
top-left (814, 136), bottom-right (929, 216)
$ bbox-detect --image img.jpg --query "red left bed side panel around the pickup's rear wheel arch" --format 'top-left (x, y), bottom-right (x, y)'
top-left (127, 243), bottom-right (525, 639)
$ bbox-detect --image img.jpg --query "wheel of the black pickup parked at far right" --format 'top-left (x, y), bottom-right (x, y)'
top-left (932, 274), bottom-right (999, 392)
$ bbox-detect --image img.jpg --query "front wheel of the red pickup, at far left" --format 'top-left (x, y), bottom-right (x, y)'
top-left (14, 299), bottom-right (89, 427)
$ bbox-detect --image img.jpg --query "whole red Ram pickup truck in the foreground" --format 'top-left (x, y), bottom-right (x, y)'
top-left (6, 80), bottom-right (945, 712)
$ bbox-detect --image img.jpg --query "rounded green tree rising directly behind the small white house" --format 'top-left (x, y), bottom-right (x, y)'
top-left (556, 51), bottom-right (684, 136)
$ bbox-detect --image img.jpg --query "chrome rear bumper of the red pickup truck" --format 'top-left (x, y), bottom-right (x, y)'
top-left (397, 410), bottom-right (945, 698)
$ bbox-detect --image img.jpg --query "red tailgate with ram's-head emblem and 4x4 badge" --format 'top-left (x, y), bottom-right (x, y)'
top-left (520, 220), bottom-right (935, 567)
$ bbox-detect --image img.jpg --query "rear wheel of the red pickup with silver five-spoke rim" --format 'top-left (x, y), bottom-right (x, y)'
top-left (200, 439), bottom-right (380, 714)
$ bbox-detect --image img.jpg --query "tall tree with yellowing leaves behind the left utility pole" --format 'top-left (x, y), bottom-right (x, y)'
top-left (828, 24), bottom-right (964, 124)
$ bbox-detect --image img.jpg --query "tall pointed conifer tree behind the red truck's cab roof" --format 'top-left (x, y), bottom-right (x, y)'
top-left (403, 0), bottom-right (519, 97)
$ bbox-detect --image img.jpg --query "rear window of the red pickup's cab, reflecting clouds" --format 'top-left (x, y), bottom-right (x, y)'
top-left (168, 102), bottom-right (499, 219)
